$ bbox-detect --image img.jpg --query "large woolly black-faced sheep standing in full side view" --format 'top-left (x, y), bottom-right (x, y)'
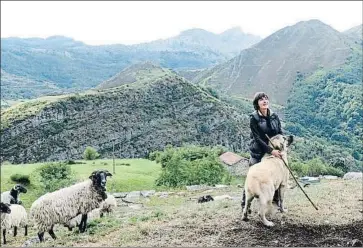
top-left (29, 170), bottom-right (112, 242)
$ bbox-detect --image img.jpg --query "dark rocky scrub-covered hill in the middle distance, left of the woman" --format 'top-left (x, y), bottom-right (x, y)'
top-left (1, 74), bottom-right (249, 163)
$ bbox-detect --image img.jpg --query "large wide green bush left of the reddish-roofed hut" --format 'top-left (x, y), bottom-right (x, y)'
top-left (156, 146), bottom-right (232, 187)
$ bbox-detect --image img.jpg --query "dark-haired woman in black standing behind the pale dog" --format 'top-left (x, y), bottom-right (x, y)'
top-left (242, 92), bottom-right (282, 208)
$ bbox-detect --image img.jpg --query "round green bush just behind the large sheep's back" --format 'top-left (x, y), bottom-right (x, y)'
top-left (33, 162), bottom-right (76, 192)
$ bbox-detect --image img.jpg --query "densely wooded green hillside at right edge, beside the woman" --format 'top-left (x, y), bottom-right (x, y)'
top-left (286, 46), bottom-right (363, 166)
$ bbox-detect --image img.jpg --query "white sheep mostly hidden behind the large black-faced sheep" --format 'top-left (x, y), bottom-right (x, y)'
top-left (64, 194), bottom-right (117, 231)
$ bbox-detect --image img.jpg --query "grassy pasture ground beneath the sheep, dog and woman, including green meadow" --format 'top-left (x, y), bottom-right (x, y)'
top-left (1, 159), bottom-right (363, 247)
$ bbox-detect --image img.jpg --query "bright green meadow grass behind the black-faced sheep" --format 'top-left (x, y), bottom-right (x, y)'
top-left (1, 159), bottom-right (161, 208)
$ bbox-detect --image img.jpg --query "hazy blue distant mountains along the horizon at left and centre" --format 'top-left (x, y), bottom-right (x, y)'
top-left (1, 27), bottom-right (259, 99)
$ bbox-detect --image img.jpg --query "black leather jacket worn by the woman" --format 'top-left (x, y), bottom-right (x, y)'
top-left (249, 110), bottom-right (282, 159)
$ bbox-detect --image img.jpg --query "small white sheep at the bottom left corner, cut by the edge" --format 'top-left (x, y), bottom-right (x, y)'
top-left (1, 204), bottom-right (28, 244)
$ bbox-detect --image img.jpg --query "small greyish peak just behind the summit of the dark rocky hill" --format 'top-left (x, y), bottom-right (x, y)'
top-left (96, 62), bottom-right (176, 89)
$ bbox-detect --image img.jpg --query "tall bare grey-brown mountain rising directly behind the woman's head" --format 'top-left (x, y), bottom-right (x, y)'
top-left (193, 20), bottom-right (352, 105)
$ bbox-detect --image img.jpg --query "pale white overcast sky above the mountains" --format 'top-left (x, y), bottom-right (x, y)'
top-left (1, 1), bottom-right (363, 45)
